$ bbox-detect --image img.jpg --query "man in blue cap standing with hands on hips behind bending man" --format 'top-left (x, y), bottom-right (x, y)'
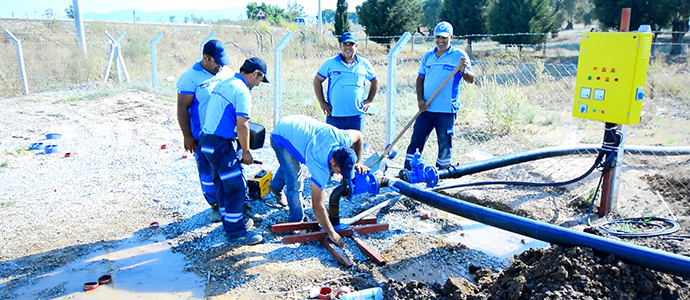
top-left (314, 32), bottom-right (379, 131)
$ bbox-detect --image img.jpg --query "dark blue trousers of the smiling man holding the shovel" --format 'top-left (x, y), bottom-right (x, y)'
top-left (405, 111), bottom-right (455, 170)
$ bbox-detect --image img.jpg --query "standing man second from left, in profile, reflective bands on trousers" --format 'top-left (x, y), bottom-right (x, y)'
top-left (199, 57), bottom-right (268, 245)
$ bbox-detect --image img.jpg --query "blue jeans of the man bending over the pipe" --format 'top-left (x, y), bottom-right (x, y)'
top-left (269, 137), bottom-right (304, 222)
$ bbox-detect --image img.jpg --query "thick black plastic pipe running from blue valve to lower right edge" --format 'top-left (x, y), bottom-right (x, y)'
top-left (391, 180), bottom-right (690, 278)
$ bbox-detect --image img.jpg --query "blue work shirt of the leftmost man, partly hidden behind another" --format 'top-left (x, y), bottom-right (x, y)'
top-left (177, 61), bottom-right (233, 141)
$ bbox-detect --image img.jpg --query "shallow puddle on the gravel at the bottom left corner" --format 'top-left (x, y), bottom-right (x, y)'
top-left (16, 236), bottom-right (206, 300)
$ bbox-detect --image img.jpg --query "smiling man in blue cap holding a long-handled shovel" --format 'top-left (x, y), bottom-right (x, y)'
top-left (405, 21), bottom-right (475, 170)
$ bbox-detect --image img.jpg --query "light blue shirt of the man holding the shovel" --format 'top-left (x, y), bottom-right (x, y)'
top-left (418, 45), bottom-right (474, 113)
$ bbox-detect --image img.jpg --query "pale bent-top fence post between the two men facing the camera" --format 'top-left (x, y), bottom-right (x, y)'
top-left (386, 31), bottom-right (412, 145)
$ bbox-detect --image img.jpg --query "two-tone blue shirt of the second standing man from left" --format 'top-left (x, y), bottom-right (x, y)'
top-left (202, 73), bottom-right (252, 139)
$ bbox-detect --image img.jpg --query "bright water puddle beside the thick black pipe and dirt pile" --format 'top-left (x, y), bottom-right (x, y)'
top-left (410, 210), bottom-right (550, 259)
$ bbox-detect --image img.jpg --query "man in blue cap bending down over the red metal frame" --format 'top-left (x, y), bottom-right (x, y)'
top-left (269, 115), bottom-right (369, 248)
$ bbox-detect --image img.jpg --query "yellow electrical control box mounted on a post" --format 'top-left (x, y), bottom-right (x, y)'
top-left (573, 32), bottom-right (652, 124)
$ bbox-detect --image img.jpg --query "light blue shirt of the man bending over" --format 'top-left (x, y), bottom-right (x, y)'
top-left (271, 115), bottom-right (354, 189)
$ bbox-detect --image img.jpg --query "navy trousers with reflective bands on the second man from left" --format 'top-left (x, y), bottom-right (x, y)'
top-left (199, 133), bottom-right (249, 238)
